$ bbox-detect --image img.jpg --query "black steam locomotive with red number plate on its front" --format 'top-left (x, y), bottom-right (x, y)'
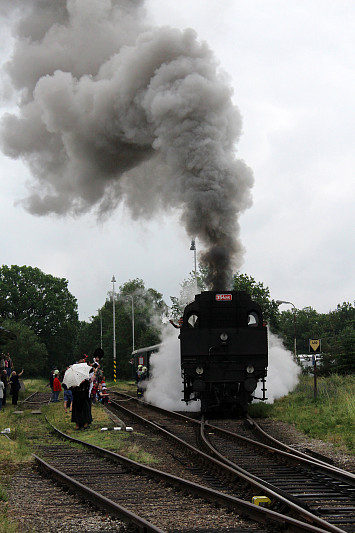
top-left (179, 291), bottom-right (268, 414)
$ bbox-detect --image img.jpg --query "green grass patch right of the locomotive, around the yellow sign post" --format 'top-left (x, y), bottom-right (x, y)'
top-left (250, 374), bottom-right (355, 454)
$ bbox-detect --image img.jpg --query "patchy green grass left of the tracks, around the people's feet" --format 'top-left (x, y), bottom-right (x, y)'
top-left (0, 379), bottom-right (155, 533)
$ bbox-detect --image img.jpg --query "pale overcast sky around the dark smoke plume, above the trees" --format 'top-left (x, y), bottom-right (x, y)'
top-left (0, 0), bottom-right (355, 320)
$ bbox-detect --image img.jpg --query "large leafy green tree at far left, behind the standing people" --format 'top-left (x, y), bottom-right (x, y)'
top-left (0, 265), bottom-right (79, 370)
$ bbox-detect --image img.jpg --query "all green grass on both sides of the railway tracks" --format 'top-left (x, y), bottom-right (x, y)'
top-left (0, 375), bottom-right (355, 533)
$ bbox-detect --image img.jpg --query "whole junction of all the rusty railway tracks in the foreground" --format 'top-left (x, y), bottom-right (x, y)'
top-left (16, 388), bottom-right (355, 533)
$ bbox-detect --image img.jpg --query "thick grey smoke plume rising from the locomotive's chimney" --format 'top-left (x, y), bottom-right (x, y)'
top-left (0, 0), bottom-right (253, 290)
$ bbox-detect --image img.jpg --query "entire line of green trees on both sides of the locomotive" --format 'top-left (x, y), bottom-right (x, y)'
top-left (0, 265), bottom-right (355, 379)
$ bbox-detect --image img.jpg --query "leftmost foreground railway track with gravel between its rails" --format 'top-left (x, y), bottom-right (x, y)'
top-left (35, 418), bottom-right (336, 533)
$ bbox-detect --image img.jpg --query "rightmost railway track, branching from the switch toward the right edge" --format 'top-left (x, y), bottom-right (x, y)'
top-left (201, 418), bottom-right (355, 532)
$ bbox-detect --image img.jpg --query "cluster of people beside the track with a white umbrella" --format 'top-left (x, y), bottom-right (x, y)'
top-left (50, 348), bottom-right (109, 430)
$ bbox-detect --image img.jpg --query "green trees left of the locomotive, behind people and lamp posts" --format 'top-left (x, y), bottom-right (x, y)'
top-left (0, 265), bottom-right (168, 378)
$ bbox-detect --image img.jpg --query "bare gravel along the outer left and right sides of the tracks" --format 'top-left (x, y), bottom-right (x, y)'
top-left (7, 419), bottom-right (355, 533)
